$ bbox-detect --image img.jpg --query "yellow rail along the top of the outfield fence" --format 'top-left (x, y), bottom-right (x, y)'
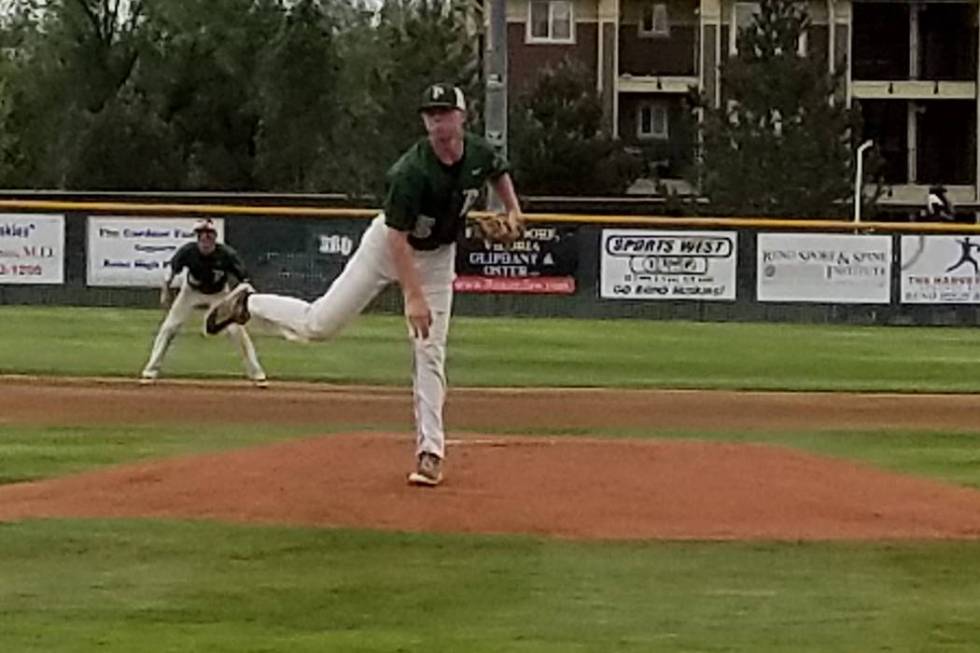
top-left (0, 200), bottom-right (980, 233)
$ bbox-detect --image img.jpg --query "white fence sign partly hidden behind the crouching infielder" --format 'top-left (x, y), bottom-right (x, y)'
top-left (88, 216), bottom-right (225, 286)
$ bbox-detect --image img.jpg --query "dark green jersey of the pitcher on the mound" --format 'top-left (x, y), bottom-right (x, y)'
top-left (384, 133), bottom-right (509, 250)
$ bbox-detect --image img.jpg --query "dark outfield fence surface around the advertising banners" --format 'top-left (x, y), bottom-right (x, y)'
top-left (0, 199), bottom-right (980, 325)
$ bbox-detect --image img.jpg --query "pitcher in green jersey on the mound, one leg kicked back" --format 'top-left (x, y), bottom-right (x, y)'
top-left (206, 84), bottom-right (524, 486)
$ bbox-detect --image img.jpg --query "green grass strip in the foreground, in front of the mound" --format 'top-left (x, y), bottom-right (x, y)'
top-left (0, 521), bottom-right (980, 653)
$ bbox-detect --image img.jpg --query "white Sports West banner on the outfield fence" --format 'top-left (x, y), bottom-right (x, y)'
top-left (599, 229), bottom-right (738, 301)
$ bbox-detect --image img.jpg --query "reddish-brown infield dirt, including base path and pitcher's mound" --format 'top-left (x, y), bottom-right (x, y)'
top-left (0, 378), bottom-right (980, 540)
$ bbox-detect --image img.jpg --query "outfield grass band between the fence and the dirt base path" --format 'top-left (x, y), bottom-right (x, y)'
top-left (0, 306), bottom-right (980, 392)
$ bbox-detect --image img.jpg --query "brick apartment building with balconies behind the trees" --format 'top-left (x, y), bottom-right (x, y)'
top-left (507, 0), bottom-right (980, 205)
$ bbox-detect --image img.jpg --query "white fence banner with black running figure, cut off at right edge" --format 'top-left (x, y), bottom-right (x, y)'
top-left (901, 235), bottom-right (980, 304)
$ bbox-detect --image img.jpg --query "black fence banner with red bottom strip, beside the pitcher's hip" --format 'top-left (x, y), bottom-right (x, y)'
top-left (453, 226), bottom-right (578, 295)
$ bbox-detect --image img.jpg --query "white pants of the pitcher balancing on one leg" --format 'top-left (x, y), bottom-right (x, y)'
top-left (248, 215), bottom-right (456, 458)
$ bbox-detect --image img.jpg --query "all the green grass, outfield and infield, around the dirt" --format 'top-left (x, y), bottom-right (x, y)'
top-left (0, 307), bottom-right (980, 653)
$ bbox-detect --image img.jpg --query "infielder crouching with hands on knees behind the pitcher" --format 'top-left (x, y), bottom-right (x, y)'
top-left (140, 220), bottom-right (268, 387)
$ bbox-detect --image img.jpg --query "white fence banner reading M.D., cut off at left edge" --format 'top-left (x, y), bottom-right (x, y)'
top-left (0, 213), bottom-right (65, 284)
